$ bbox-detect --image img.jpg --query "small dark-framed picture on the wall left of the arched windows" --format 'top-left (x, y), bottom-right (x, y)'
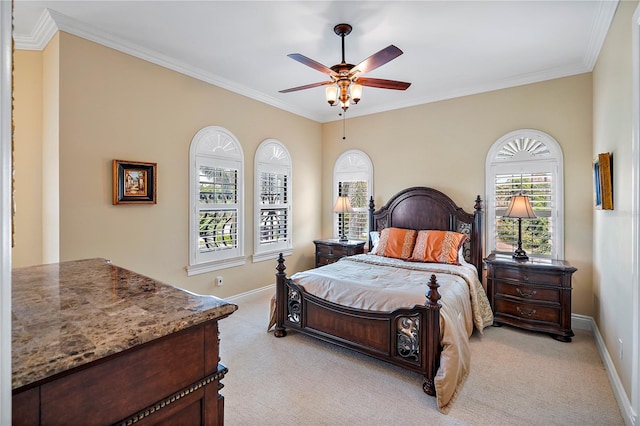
top-left (113, 160), bottom-right (157, 204)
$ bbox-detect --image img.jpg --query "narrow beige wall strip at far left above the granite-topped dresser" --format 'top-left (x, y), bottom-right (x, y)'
top-left (12, 51), bottom-right (43, 267)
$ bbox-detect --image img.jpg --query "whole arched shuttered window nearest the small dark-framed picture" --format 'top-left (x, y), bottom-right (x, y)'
top-left (187, 126), bottom-right (246, 275)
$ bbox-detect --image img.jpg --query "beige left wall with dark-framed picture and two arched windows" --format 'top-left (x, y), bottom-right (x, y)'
top-left (16, 33), bottom-right (321, 297)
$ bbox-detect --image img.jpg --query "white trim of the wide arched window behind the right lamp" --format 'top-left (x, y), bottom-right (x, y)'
top-left (485, 129), bottom-right (564, 259)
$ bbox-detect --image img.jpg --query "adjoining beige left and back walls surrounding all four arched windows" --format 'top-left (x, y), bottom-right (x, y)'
top-left (18, 33), bottom-right (593, 315)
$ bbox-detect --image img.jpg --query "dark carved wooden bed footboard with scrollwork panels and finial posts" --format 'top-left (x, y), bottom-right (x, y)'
top-left (274, 254), bottom-right (441, 396)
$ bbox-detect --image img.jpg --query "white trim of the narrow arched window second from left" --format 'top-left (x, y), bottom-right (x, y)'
top-left (253, 139), bottom-right (293, 263)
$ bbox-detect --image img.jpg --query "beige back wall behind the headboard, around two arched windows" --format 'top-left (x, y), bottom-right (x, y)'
top-left (322, 73), bottom-right (593, 316)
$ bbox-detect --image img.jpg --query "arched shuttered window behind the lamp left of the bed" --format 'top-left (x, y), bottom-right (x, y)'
top-left (332, 149), bottom-right (373, 241)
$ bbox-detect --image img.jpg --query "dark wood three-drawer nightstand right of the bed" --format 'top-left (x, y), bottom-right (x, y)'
top-left (484, 253), bottom-right (577, 342)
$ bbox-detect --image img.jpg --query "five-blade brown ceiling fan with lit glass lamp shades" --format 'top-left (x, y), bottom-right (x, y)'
top-left (280, 24), bottom-right (411, 111)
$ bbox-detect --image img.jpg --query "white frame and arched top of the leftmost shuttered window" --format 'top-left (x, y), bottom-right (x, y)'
top-left (186, 126), bottom-right (246, 276)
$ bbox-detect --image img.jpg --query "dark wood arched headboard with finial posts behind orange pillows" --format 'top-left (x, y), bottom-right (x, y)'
top-left (369, 186), bottom-right (483, 278)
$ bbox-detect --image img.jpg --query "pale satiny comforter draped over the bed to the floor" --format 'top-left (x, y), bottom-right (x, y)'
top-left (291, 254), bottom-right (493, 413)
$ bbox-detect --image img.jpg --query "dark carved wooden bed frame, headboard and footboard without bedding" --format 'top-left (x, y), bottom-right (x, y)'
top-left (274, 187), bottom-right (482, 402)
